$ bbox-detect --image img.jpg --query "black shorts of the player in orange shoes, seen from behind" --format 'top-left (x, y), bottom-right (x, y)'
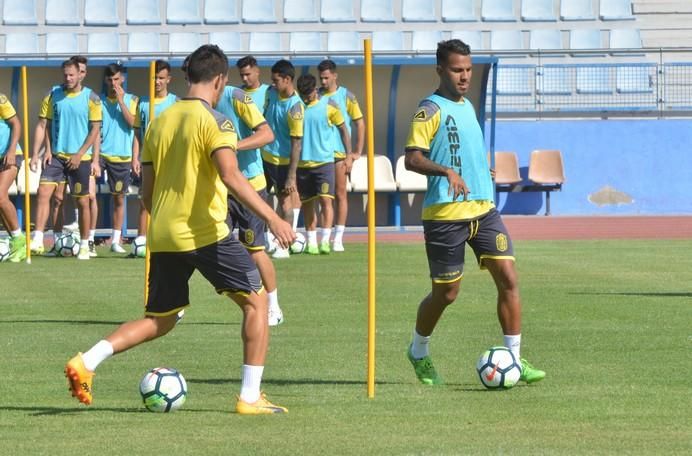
top-left (144, 235), bottom-right (262, 317)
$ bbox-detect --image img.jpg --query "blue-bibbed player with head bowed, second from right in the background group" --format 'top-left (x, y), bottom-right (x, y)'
top-left (297, 74), bottom-right (351, 255)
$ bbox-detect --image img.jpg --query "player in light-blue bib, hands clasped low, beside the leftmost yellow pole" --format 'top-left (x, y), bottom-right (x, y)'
top-left (30, 60), bottom-right (101, 260)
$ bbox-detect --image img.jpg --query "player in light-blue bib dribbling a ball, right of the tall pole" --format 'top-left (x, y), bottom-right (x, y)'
top-left (405, 39), bottom-right (545, 385)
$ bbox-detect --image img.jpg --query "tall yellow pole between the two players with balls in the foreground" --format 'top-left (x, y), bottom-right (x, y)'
top-left (364, 39), bottom-right (375, 399)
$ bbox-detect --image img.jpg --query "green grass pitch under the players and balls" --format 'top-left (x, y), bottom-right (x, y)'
top-left (0, 240), bottom-right (692, 455)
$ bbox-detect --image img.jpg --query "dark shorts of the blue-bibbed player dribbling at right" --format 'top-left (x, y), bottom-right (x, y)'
top-left (423, 208), bottom-right (514, 283)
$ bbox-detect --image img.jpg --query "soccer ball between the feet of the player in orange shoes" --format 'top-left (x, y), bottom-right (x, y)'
top-left (139, 367), bottom-right (187, 413)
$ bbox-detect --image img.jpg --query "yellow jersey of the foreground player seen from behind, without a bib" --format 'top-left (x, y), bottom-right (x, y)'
top-left (142, 98), bottom-right (238, 252)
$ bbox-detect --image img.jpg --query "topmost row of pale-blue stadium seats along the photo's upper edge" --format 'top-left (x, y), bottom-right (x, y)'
top-left (2, 0), bottom-right (634, 26)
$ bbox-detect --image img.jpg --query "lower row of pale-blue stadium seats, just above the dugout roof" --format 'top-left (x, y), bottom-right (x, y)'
top-left (4, 29), bottom-right (642, 54)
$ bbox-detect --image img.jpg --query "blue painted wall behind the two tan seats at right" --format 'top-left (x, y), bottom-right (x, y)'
top-left (486, 119), bottom-right (692, 215)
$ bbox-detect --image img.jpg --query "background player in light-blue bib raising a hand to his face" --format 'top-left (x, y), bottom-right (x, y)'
top-left (100, 63), bottom-right (139, 253)
